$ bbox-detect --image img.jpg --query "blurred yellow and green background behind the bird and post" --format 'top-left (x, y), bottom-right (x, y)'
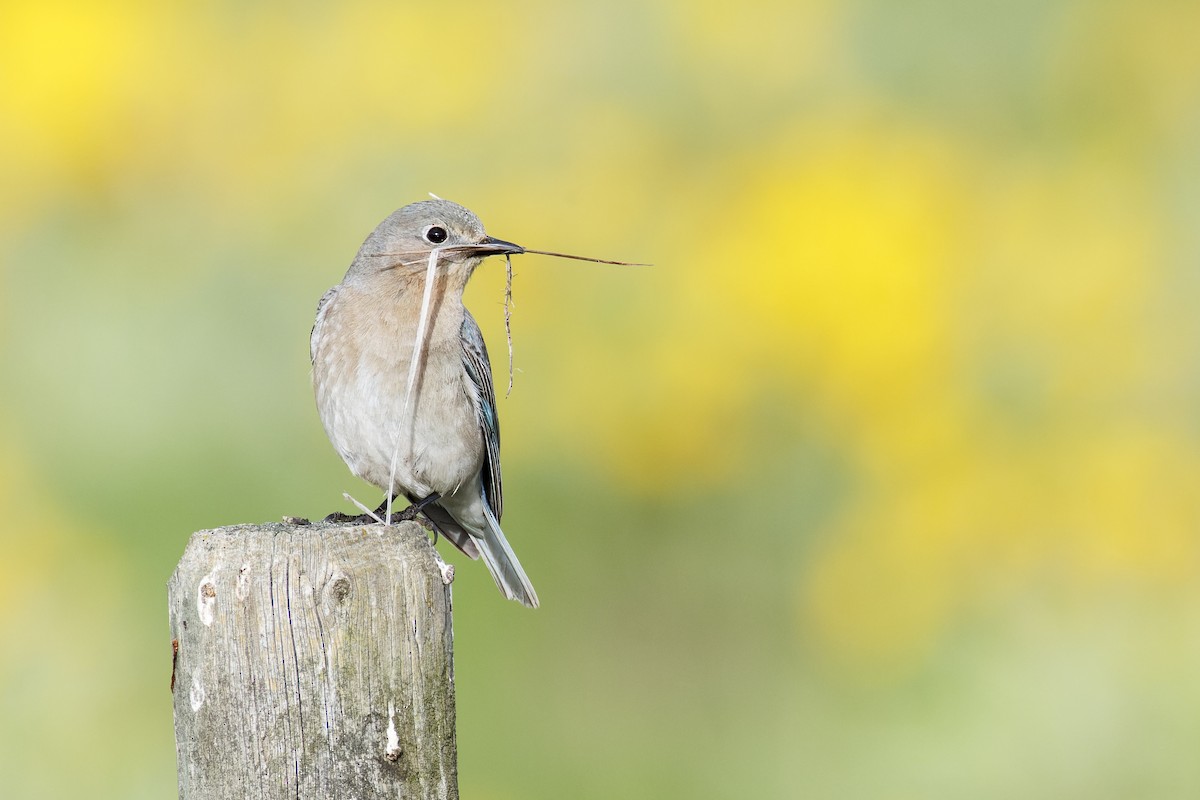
top-left (0, 0), bottom-right (1200, 800)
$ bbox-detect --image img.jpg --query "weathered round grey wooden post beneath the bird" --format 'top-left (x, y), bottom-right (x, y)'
top-left (168, 523), bottom-right (458, 800)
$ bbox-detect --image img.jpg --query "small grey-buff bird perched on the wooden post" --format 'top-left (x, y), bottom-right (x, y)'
top-left (310, 198), bottom-right (539, 608)
